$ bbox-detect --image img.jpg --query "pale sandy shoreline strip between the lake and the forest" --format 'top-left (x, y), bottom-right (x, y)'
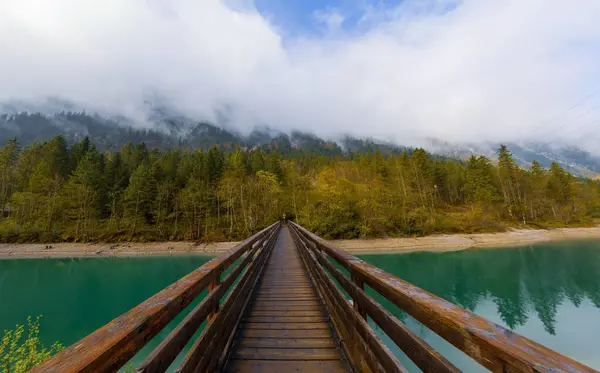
top-left (0, 226), bottom-right (600, 259)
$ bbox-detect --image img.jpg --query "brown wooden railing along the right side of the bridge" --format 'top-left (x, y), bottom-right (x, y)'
top-left (290, 223), bottom-right (596, 372)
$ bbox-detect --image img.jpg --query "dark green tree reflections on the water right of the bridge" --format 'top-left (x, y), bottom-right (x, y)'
top-left (362, 243), bottom-right (600, 335)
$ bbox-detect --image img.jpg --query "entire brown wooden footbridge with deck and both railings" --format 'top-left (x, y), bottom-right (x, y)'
top-left (32, 223), bottom-right (595, 373)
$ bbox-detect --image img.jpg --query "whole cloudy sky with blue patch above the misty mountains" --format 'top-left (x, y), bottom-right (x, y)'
top-left (0, 0), bottom-right (600, 150)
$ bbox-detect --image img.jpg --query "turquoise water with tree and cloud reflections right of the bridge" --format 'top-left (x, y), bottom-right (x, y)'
top-left (361, 241), bottom-right (600, 372)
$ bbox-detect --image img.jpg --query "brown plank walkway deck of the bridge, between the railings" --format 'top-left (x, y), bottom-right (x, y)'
top-left (225, 227), bottom-right (350, 372)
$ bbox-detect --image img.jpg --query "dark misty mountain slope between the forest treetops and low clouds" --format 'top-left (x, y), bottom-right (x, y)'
top-left (0, 110), bottom-right (600, 178)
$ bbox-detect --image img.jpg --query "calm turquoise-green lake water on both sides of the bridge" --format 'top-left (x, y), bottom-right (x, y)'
top-left (0, 241), bottom-right (600, 371)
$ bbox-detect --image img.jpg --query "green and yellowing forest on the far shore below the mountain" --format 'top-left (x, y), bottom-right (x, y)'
top-left (0, 136), bottom-right (600, 242)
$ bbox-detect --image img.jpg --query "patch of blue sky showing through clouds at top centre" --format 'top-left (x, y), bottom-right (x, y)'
top-left (255, 0), bottom-right (402, 37)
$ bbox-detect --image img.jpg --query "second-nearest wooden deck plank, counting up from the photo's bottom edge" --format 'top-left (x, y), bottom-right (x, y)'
top-left (231, 347), bottom-right (342, 361)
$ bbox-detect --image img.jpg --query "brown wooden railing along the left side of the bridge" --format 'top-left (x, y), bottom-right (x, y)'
top-left (31, 223), bottom-right (280, 373)
